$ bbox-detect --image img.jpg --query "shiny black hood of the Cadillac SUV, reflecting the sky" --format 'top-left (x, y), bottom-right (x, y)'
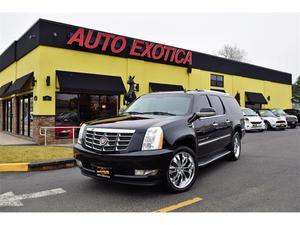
top-left (86, 115), bottom-right (182, 132)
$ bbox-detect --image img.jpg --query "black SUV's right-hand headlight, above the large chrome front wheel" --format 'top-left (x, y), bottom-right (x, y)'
top-left (142, 127), bottom-right (163, 150)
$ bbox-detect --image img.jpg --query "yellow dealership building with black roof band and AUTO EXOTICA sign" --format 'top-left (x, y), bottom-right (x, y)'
top-left (0, 19), bottom-right (292, 143)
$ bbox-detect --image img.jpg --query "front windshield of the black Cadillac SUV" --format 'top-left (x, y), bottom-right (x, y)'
top-left (123, 94), bottom-right (193, 116)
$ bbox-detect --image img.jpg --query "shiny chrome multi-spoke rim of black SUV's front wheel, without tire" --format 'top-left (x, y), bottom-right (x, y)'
top-left (169, 152), bottom-right (195, 189)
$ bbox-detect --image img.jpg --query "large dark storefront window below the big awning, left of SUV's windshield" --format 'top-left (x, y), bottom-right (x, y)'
top-left (55, 93), bottom-right (119, 138)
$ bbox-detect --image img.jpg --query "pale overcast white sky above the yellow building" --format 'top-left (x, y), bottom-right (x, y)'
top-left (0, 12), bottom-right (300, 81)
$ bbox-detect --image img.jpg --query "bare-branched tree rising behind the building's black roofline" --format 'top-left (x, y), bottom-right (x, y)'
top-left (217, 44), bottom-right (248, 62)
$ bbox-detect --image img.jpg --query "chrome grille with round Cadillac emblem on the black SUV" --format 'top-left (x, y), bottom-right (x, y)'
top-left (85, 128), bottom-right (135, 152)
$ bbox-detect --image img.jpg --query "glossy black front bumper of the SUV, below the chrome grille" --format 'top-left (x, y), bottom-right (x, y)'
top-left (74, 144), bottom-right (173, 186)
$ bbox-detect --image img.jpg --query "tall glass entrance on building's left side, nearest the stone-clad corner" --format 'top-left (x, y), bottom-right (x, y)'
top-left (18, 96), bottom-right (33, 137)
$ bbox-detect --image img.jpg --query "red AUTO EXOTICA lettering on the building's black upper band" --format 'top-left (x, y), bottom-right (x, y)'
top-left (67, 28), bottom-right (192, 65)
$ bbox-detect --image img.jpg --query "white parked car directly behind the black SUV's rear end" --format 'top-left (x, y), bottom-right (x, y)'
top-left (242, 108), bottom-right (266, 132)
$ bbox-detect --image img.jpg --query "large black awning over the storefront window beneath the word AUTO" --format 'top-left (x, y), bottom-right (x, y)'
top-left (56, 71), bottom-right (126, 95)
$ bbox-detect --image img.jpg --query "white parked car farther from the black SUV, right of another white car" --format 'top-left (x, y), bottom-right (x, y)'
top-left (258, 109), bottom-right (287, 130)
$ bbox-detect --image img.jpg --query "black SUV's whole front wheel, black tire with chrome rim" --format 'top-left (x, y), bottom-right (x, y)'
top-left (163, 146), bottom-right (198, 193)
